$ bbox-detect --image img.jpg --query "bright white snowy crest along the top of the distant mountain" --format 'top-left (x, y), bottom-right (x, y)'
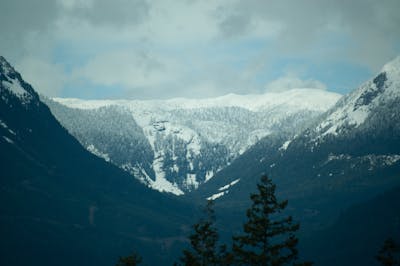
top-left (53, 88), bottom-right (341, 112)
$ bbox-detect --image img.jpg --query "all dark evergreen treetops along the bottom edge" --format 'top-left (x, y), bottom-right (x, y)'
top-left (117, 176), bottom-right (400, 266)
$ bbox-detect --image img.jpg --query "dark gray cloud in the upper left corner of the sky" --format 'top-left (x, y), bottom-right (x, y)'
top-left (0, 0), bottom-right (150, 61)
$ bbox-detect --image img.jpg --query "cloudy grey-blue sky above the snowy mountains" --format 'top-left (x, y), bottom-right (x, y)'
top-left (0, 0), bottom-right (400, 99)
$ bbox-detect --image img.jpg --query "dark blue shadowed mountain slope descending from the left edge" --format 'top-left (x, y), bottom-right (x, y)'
top-left (0, 57), bottom-right (193, 265)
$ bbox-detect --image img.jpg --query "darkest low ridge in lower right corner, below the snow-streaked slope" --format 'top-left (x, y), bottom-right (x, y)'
top-left (303, 187), bottom-right (400, 266)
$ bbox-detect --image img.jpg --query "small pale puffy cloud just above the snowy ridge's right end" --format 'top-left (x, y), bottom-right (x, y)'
top-left (265, 74), bottom-right (327, 92)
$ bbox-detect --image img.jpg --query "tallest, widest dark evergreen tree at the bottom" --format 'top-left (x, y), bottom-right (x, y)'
top-left (233, 175), bottom-right (311, 266)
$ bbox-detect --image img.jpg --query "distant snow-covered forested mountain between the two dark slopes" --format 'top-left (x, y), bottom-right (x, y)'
top-left (46, 89), bottom-right (341, 195)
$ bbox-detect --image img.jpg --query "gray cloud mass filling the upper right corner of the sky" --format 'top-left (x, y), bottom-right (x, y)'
top-left (219, 0), bottom-right (400, 70)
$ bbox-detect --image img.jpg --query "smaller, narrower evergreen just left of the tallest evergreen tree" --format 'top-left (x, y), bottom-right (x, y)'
top-left (177, 201), bottom-right (226, 266)
